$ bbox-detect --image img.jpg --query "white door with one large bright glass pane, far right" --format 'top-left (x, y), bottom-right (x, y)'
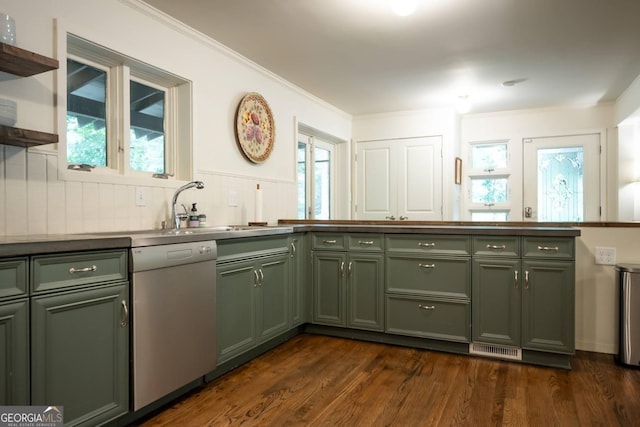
top-left (523, 134), bottom-right (600, 222)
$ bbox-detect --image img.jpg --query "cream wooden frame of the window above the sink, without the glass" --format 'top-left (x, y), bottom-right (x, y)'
top-left (57, 28), bottom-right (193, 187)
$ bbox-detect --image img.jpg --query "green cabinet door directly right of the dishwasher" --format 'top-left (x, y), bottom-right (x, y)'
top-left (216, 261), bottom-right (259, 364)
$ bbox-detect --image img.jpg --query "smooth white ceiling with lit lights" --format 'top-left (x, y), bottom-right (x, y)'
top-left (144, 0), bottom-right (640, 115)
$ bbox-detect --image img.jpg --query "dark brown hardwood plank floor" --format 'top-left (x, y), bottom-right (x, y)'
top-left (139, 334), bottom-right (640, 427)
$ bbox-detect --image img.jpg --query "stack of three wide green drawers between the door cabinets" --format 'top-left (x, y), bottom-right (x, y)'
top-left (385, 234), bottom-right (471, 343)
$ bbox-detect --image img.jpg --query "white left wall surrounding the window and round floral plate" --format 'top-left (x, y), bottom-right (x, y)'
top-left (0, 0), bottom-right (351, 235)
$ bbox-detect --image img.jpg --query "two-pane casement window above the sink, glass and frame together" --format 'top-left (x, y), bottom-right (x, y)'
top-left (65, 34), bottom-right (192, 180)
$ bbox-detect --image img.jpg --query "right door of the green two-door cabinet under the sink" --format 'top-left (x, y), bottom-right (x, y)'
top-left (256, 254), bottom-right (289, 343)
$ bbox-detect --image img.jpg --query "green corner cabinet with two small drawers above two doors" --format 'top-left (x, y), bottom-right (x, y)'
top-left (312, 233), bottom-right (384, 331)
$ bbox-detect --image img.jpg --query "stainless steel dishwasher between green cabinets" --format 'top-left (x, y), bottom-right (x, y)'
top-left (131, 240), bottom-right (217, 410)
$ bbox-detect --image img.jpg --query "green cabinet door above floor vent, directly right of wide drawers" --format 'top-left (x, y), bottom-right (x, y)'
top-left (471, 258), bottom-right (522, 347)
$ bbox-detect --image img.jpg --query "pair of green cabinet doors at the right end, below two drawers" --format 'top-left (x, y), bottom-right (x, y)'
top-left (472, 258), bottom-right (575, 354)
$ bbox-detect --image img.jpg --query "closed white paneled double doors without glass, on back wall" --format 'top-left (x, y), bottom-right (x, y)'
top-left (355, 136), bottom-right (442, 221)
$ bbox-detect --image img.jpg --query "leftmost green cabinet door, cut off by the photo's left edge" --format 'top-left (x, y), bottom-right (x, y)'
top-left (0, 299), bottom-right (29, 405)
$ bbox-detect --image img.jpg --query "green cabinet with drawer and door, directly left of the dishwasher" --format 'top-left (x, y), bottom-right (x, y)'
top-left (30, 249), bottom-right (130, 425)
